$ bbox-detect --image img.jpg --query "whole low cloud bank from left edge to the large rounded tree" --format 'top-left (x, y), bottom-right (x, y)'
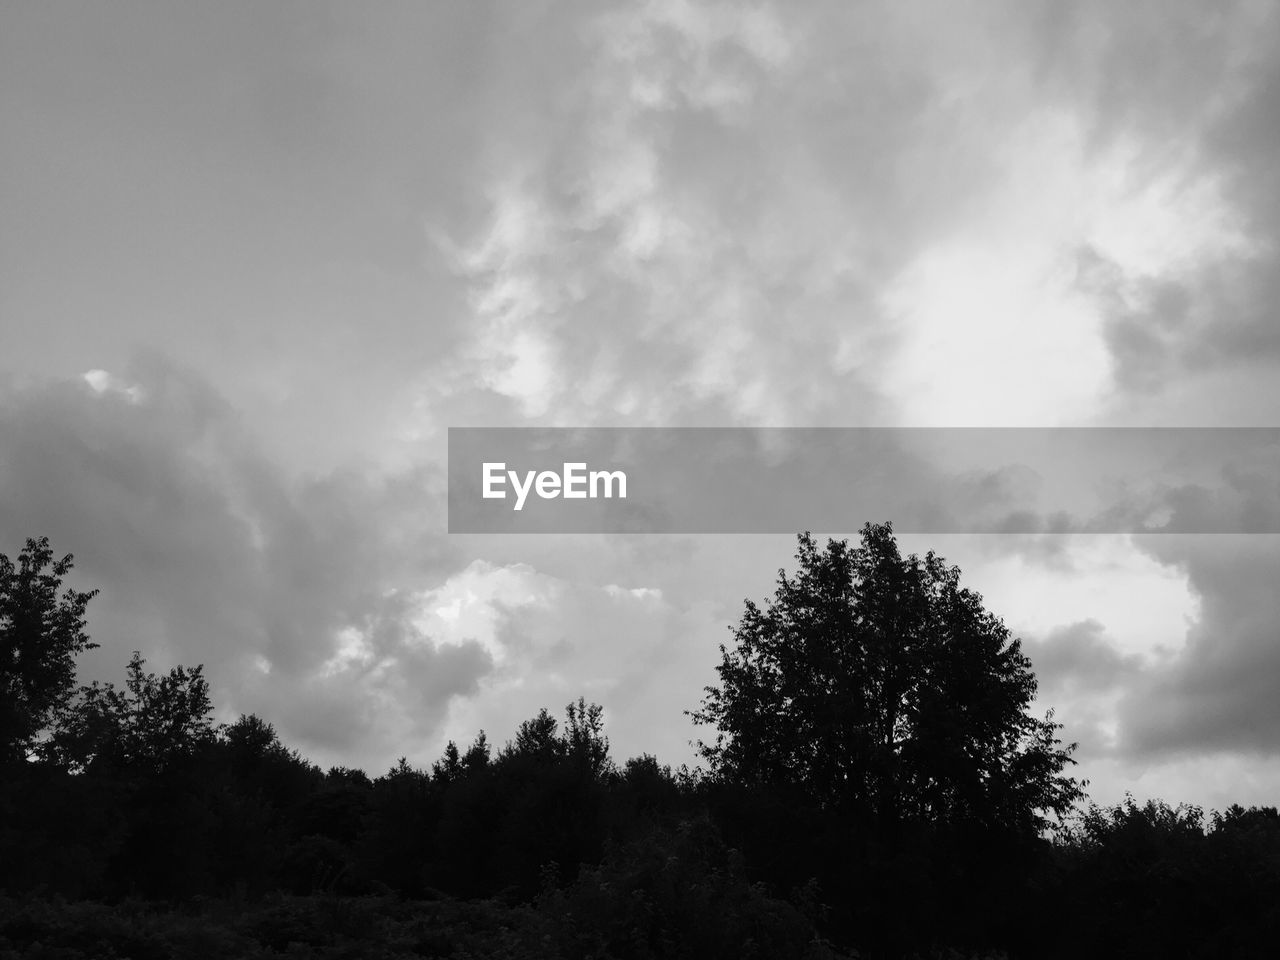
top-left (0, 357), bottom-right (742, 769)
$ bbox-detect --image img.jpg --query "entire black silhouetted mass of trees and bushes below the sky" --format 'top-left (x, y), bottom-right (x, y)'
top-left (0, 525), bottom-right (1280, 960)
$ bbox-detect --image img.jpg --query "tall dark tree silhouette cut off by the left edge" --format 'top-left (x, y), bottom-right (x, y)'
top-left (0, 536), bottom-right (97, 760)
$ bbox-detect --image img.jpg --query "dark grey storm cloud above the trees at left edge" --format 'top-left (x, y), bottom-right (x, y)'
top-left (0, 360), bottom-right (490, 750)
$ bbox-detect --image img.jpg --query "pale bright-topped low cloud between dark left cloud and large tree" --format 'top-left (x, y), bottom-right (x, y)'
top-left (404, 561), bottom-right (723, 759)
